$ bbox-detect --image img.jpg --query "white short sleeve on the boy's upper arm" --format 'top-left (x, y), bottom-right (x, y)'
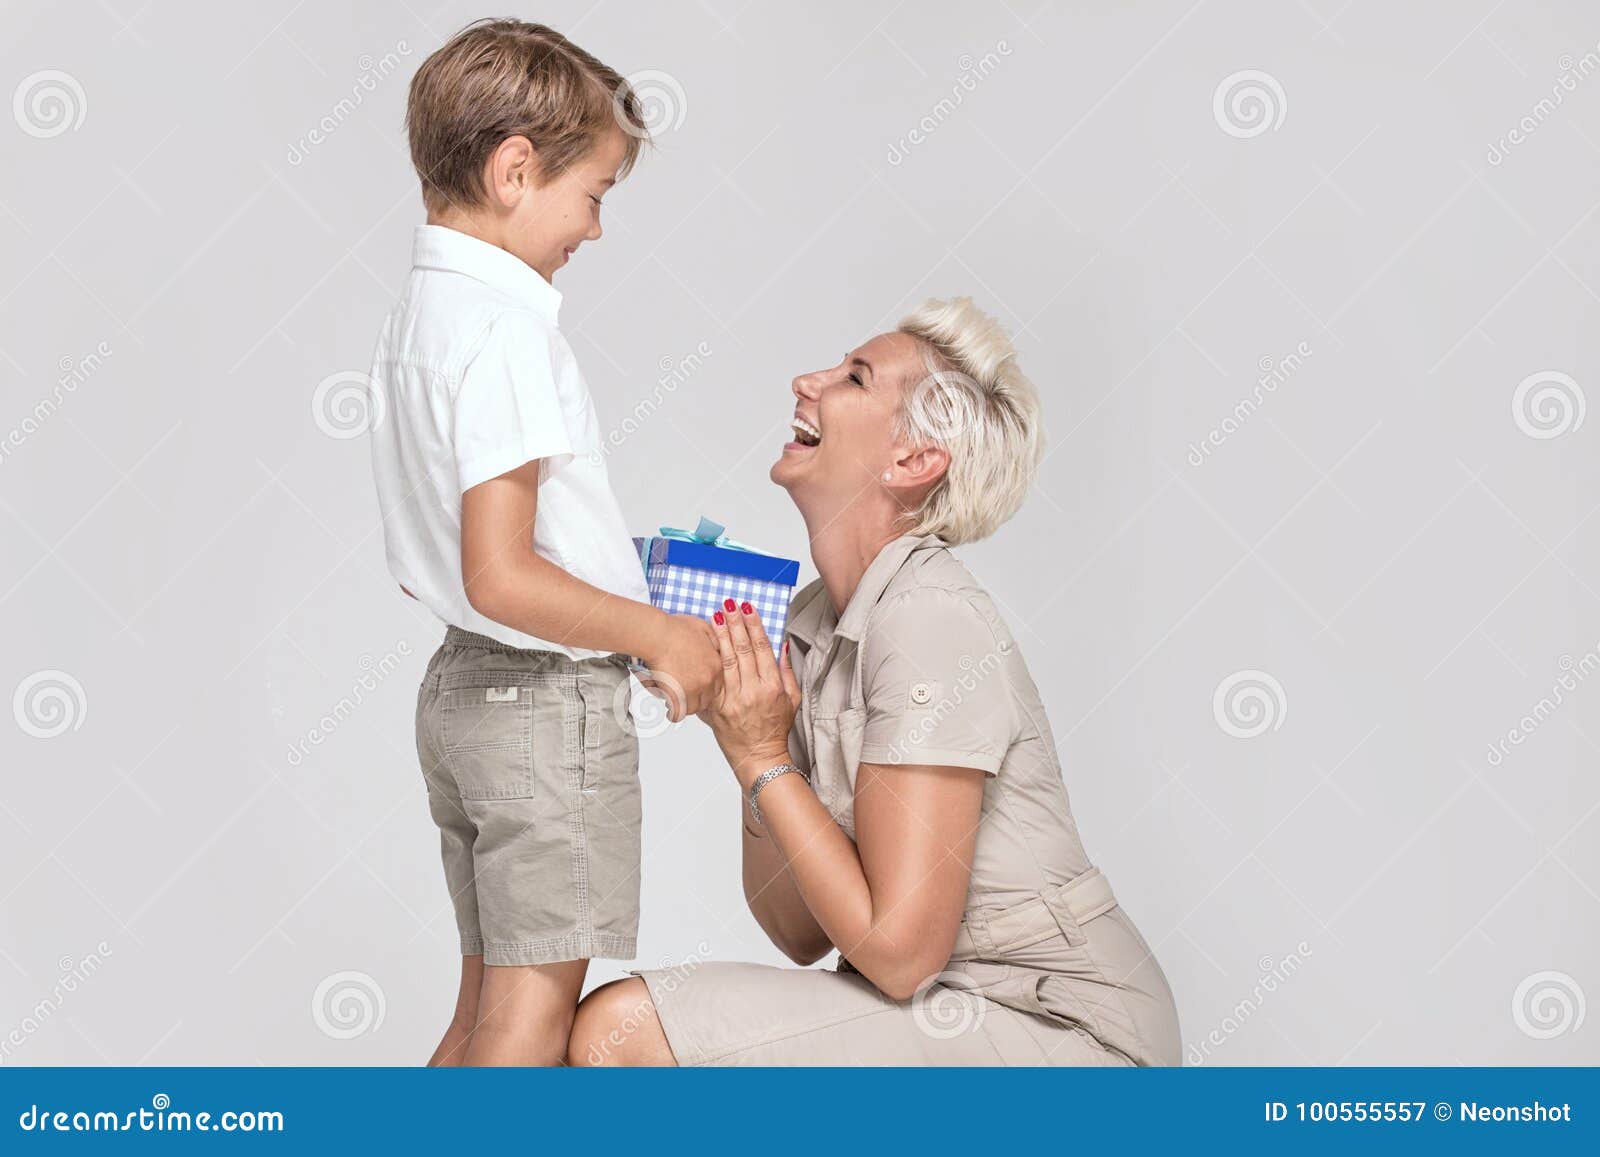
top-left (454, 314), bottom-right (573, 493)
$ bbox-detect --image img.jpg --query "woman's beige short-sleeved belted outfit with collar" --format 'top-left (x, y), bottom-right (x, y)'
top-left (635, 534), bottom-right (1181, 1066)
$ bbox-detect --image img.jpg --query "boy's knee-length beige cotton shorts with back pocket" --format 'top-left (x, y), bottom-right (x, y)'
top-left (416, 627), bottom-right (642, 965)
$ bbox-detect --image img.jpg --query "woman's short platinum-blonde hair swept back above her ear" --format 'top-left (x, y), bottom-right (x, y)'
top-left (894, 298), bottom-right (1045, 546)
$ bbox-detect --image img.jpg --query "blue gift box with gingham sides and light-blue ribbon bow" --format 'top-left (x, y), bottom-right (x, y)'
top-left (634, 518), bottom-right (800, 651)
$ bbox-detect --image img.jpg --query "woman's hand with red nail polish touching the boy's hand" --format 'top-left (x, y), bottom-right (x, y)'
top-left (699, 599), bottom-right (800, 789)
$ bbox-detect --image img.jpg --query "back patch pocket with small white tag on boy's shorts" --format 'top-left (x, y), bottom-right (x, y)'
top-left (438, 685), bottom-right (536, 800)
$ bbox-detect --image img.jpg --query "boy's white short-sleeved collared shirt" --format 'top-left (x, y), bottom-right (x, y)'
top-left (371, 226), bottom-right (650, 659)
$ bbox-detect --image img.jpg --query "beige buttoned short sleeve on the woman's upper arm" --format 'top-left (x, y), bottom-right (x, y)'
top-left (861, 587), bottom-right (1014, 775)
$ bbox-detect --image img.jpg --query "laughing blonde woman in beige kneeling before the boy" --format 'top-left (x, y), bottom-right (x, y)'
top-left (568, 298), bottom-right (1179, 1066)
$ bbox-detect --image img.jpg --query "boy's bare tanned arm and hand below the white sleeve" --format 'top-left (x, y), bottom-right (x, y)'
top-left (461, 459), bottom-right (722, 712)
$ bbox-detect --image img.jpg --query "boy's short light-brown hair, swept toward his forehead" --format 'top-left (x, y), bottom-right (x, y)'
top-left (405, 19), bottom-right (648, 213)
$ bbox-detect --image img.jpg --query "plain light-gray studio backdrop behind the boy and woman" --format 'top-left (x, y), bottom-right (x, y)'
top-left (0, 0), bottom-right (1600, 1064)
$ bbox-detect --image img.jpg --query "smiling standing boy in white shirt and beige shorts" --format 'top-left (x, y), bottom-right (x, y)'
top-left (373, 21), bottom-right (722, 1064)
